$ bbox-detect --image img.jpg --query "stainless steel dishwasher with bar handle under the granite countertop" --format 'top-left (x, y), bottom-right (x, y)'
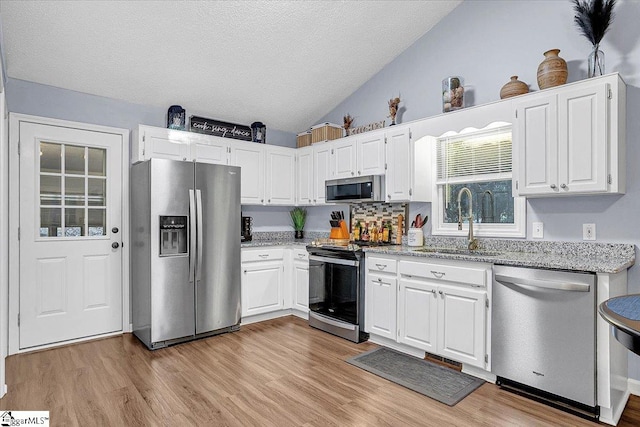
top-left (491, 265), bottom-right (599, 419)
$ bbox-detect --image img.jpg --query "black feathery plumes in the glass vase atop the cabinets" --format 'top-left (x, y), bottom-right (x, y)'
top-left (573, 0), bottom-right (616, 47)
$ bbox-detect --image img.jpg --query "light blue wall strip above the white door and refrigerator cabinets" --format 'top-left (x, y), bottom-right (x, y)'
top-left (7, 78), bottom-right (296, 147)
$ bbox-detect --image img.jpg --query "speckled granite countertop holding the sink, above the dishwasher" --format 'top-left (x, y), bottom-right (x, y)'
top-left (364, 237), bottom-right (635, 273)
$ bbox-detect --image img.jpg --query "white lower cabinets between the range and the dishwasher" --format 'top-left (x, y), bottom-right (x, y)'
top-left (365, 255), bottom-right (491, 369)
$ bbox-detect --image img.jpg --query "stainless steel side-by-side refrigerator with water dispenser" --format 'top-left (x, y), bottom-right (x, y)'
top-left (131, 159), bottom-right (241, 349)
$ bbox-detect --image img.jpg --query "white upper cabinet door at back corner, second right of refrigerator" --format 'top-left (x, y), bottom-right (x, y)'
top-left (265, 145), bottom-right (296, 206)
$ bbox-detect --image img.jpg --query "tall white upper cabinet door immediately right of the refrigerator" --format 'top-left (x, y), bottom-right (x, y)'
top-left (229, 141), bottom-right (265, 205)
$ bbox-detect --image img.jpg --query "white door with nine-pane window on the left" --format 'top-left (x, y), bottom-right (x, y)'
top-left (19, 122), bottom-right (122, 349)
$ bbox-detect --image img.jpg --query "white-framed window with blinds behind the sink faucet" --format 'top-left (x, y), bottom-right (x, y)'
top-left (431, 122), bottom-right (526, 237)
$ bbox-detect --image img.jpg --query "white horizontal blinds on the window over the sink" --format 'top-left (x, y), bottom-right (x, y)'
top-left (436, 126), bottom-right (511, 184)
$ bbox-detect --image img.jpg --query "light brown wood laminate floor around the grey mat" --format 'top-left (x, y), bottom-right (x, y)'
top-left (0, 316), bottom-right (640, 427)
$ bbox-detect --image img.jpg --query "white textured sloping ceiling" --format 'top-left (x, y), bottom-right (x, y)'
top-left (0, 0), bottom-right (461, 132)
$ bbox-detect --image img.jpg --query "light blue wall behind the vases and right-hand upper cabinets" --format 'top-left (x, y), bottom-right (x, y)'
top-left (317, 0), bottom-right (640, 380)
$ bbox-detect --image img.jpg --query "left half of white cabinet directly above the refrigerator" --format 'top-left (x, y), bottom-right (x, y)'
top-left (131, 125), bottom-right (191, 163)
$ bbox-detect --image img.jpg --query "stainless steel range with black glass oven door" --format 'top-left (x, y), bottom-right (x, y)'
top-left (307, 242), bottom-right (369, 343)
